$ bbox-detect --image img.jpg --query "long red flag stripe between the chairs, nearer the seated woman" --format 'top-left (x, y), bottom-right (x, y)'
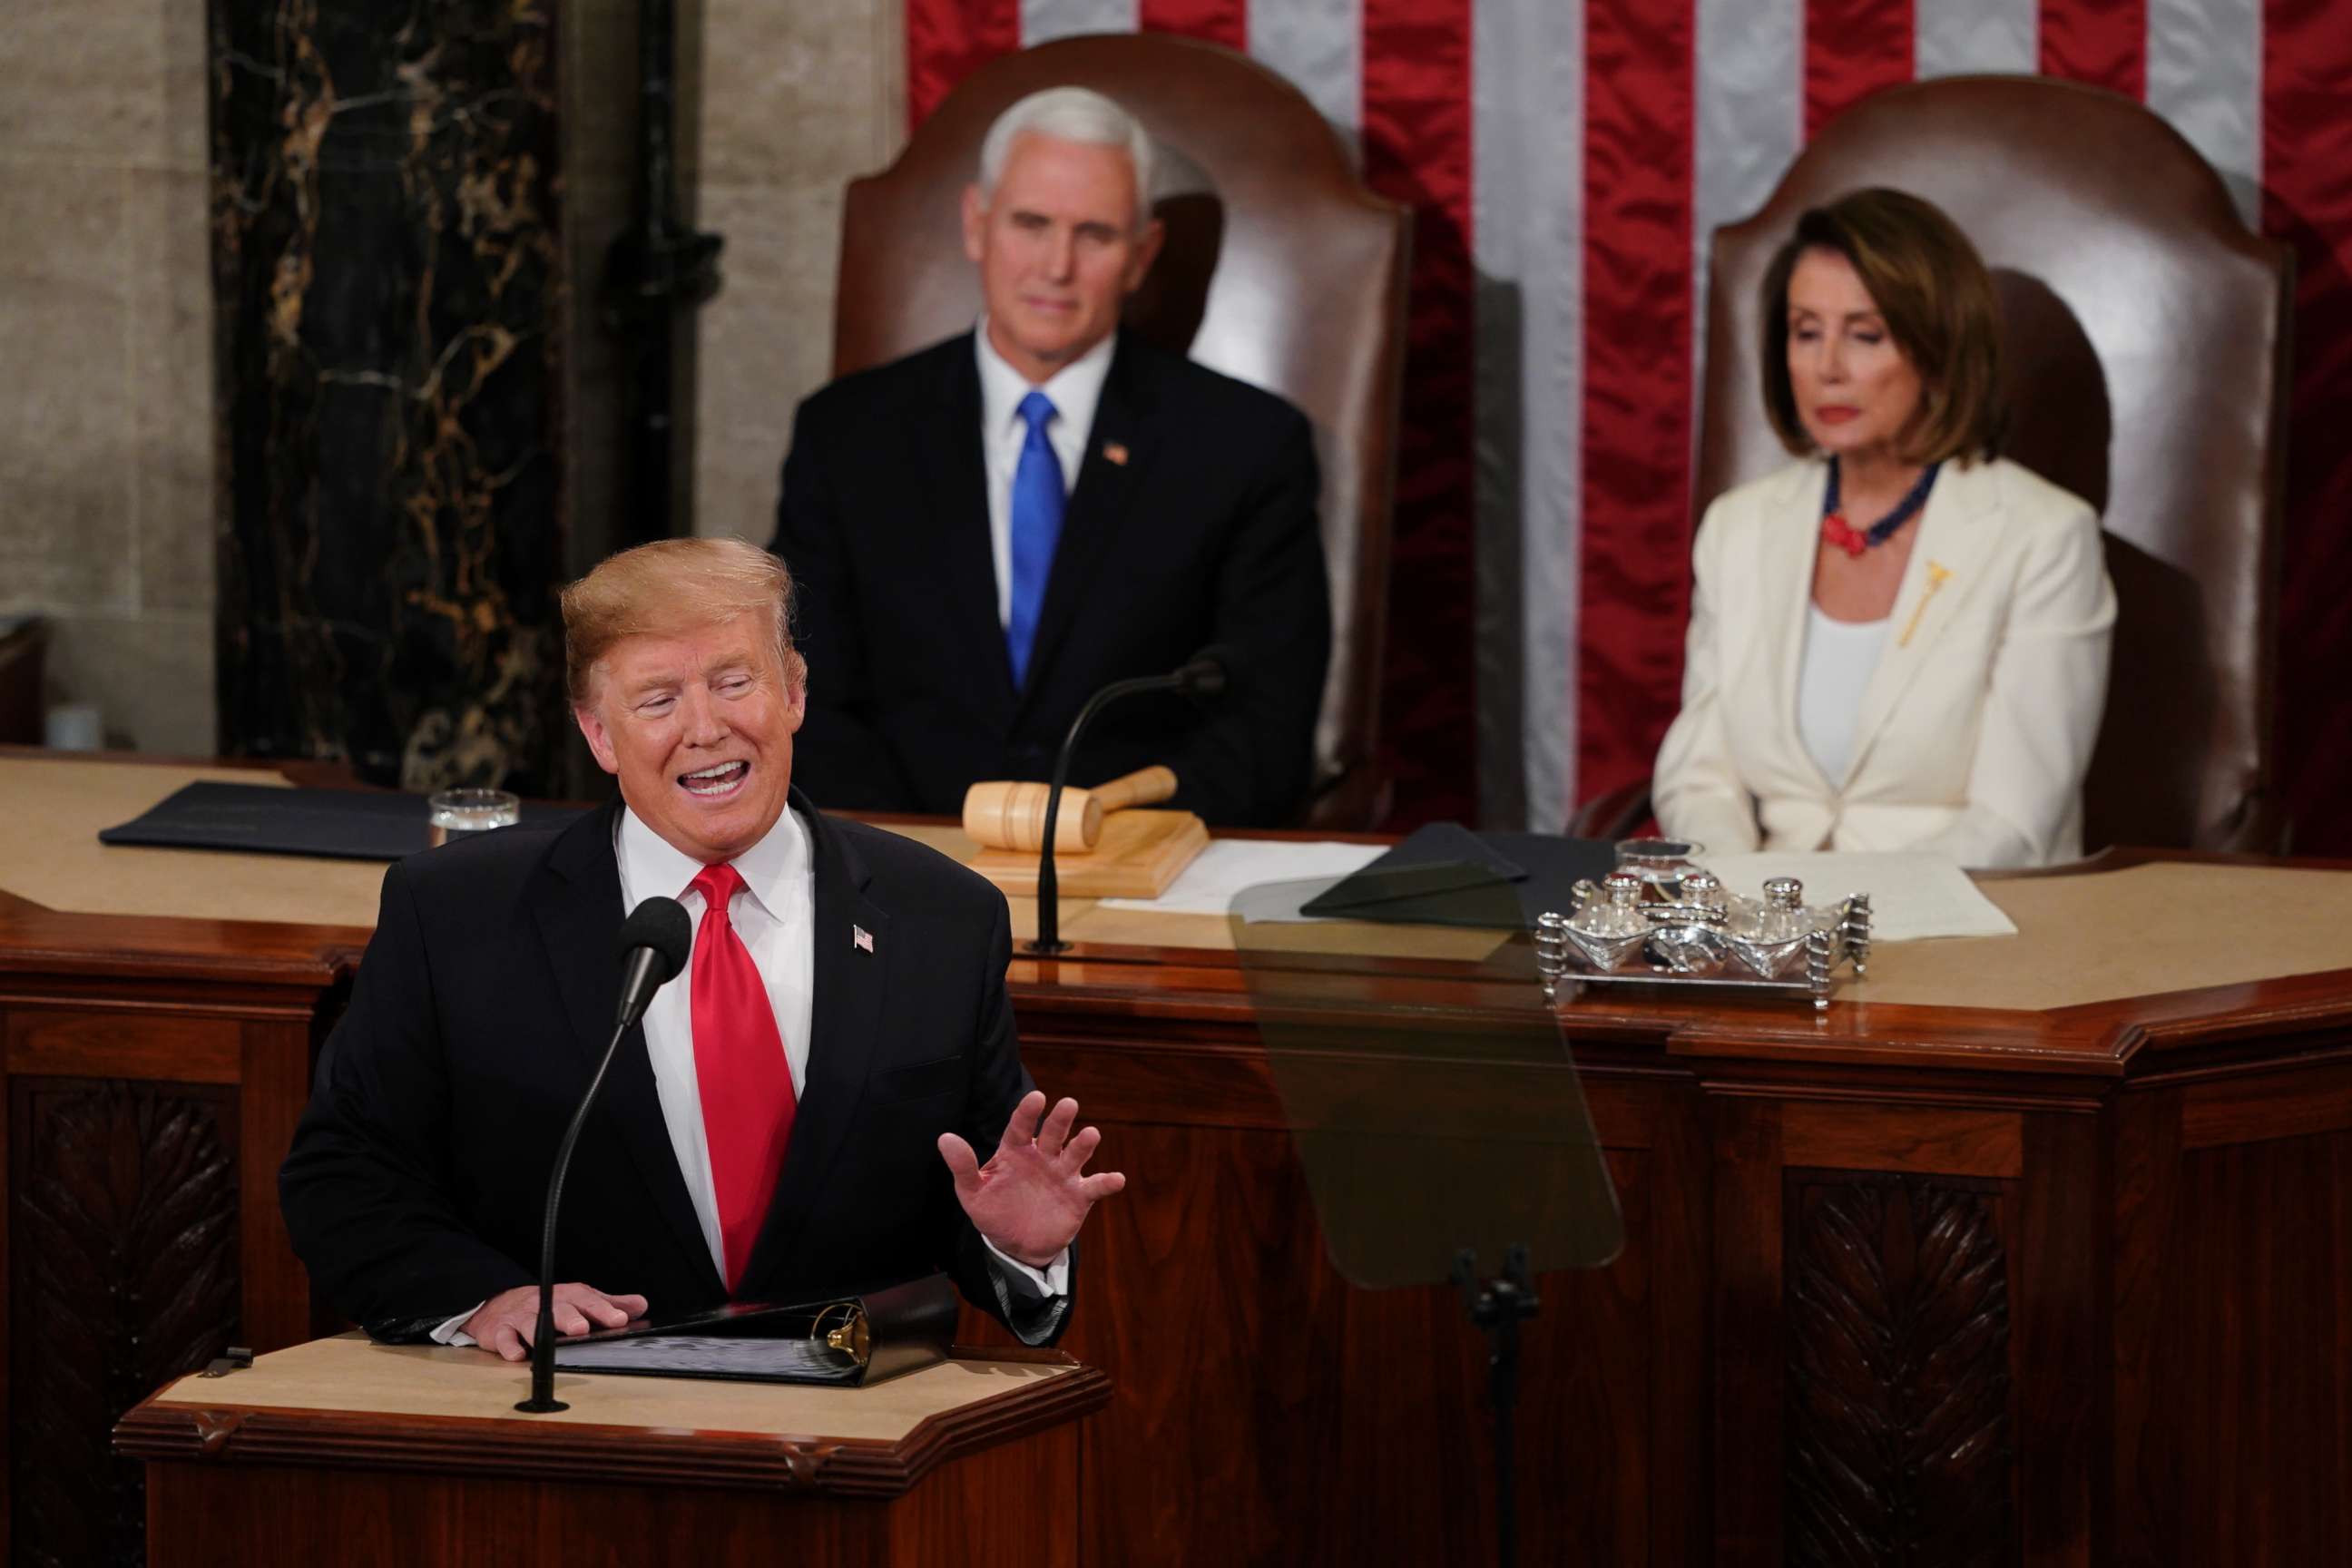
top-left (1576, 0), bottom-right (1696, 799)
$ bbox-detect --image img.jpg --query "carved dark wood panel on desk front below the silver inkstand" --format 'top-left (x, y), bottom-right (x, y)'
top-left (1783, 1173), bottom-right (2018, 1568)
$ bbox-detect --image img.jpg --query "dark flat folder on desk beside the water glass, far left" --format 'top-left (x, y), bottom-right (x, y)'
top-left (99, 780), bottom-right (579, 860)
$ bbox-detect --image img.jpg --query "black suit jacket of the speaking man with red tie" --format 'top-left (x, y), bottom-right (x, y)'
top-left (278, 789), bottom-right (1068, 1340)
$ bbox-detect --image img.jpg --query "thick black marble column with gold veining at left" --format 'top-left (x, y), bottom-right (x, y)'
top-left (210, 0), bottom-right (572, 792)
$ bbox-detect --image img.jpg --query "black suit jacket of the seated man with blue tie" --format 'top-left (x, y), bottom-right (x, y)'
top-left (774, 331), bottom-right (1331, 825)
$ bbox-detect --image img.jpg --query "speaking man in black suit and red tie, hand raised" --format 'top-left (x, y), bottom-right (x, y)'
top-left (279, 538), bottom-right (1124, 1358)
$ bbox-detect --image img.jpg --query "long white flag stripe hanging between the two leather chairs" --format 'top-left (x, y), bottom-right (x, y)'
top-left (1470, 0), bottom-right (1585, 830)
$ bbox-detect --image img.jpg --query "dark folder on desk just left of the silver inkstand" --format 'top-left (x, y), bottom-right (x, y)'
top-left (1300, 823), bottom-right (1616, 926)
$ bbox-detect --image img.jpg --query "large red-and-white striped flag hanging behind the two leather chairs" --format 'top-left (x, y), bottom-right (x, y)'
top-left (906, 0), bottom-right (2352, 853)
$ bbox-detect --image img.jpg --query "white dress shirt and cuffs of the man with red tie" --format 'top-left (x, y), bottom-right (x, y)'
top-left (433, 811), bottom-right (1070, 1345)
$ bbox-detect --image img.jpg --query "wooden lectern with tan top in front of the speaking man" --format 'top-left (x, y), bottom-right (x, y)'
top-left (115, 1333), bottom-right (1110, 1568)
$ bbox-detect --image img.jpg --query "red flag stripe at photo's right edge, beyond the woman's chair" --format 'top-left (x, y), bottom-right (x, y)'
top-left (2263, 0), bottom-right (2352, 856)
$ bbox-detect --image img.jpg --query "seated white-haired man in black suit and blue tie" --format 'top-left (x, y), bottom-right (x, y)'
top-left (774, 87), bottom-right (1331, 825)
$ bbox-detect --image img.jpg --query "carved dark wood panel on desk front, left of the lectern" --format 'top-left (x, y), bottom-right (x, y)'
top-left (7, 1077), bottom-right (238, 1568)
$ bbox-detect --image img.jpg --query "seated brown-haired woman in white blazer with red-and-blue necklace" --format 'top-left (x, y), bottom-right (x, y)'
top-left (1651, 191), bottom-right (2114, 865)
